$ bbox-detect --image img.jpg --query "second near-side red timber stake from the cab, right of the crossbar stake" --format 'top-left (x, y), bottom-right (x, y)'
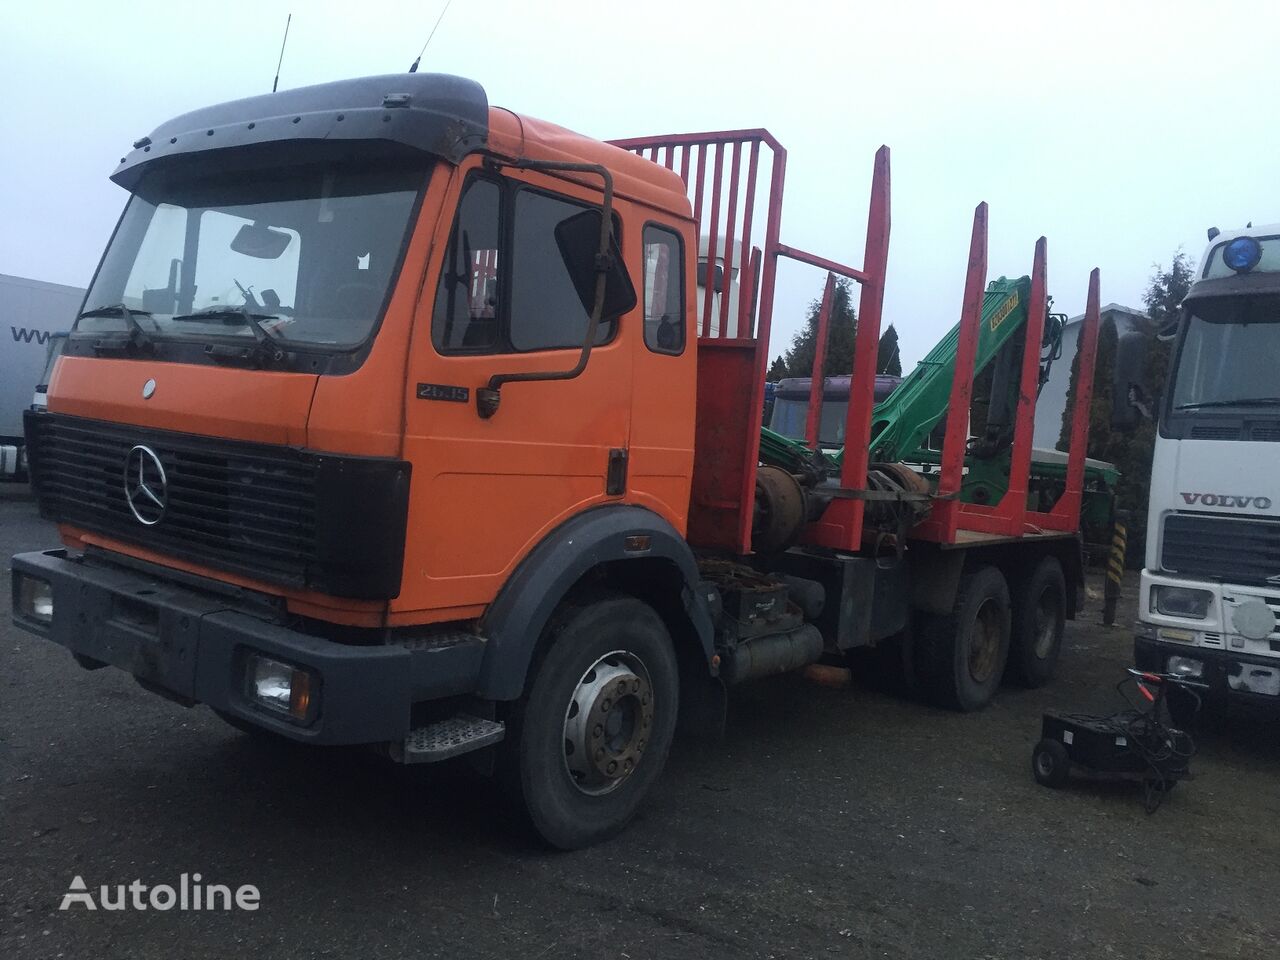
top-left (931, 201), bottom-right (987, 543)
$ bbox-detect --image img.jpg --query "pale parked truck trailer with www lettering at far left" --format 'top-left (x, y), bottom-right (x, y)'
top-left (0, 274), bottom-right (84, 480)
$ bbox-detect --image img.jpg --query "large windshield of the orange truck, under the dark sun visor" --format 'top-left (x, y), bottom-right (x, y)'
top-left (76, 164), bottom-right (426, 348)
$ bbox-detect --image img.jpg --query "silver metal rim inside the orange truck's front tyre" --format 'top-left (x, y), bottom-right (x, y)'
top-left (564, 650), bottom-right (654, 796)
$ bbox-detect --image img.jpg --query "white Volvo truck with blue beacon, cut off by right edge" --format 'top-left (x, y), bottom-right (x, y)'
top-left (1115, 224), bottom-right (1280, 717)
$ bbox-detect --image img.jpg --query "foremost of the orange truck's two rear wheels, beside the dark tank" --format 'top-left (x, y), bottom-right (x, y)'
top-left (913, 566), bottom-right (1010, 713)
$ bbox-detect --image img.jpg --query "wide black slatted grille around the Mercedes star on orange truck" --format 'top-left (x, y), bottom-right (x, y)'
top-left (26, 413), bottom-right (410, 599)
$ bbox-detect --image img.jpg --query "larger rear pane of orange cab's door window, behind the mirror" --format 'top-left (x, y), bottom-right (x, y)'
top-left (511, 189), bottom-right (617, 352)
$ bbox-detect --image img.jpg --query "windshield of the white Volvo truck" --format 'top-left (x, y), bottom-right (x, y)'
top-left (1171, 297), bottom-right (1280, 411)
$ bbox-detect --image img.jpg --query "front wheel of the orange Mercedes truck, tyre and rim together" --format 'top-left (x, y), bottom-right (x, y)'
top-left (503, 594), bottom-right (680, 850)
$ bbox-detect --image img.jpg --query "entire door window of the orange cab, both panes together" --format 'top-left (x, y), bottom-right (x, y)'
top-left (431, 177), bottom-right (624, 353)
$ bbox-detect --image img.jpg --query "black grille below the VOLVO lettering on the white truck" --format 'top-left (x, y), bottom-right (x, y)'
top-left (1160, 513), bottom-right (1280, 584)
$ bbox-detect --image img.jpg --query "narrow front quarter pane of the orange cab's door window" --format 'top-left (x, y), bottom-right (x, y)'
top-left (431, 179), bottom-right (502, 353)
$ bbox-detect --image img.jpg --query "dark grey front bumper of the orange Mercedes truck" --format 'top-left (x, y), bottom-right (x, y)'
top-left (13, 550), bottom-right (483, 744)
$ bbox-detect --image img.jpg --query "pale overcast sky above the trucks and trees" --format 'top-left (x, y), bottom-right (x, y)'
top-left (0, 0), bottom-right (1280, 369)
